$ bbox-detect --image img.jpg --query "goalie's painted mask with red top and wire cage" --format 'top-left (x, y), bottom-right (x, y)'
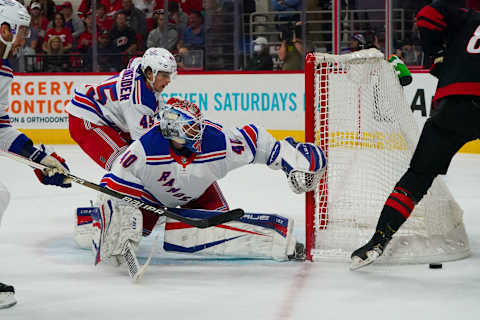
top-left (160, 98), bottom-right (205, 152)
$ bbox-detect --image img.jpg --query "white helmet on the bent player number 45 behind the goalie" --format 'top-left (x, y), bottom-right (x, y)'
top-left (141, 48), bottom-right (177, 85)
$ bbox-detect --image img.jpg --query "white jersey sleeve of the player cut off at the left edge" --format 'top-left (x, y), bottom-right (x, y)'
top-left (0, 59), bottom-right (30, 153)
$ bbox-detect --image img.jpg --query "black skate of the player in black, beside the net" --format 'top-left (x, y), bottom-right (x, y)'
top-left (350, 230), bottom-right (392, 270)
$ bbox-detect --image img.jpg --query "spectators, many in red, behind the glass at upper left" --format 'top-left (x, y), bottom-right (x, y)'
top-left (19, 0), bottom-right (205, 72)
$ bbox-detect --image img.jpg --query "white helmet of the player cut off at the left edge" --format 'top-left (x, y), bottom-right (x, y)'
top-left (0, 0), bottom-right (30, 59)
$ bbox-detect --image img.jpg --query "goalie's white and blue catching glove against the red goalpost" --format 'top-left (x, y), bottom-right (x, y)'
top-left (267, 137), bottom-right (327, 193)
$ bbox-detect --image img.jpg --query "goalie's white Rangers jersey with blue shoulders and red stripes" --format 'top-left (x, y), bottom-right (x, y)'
top-left (101, 120), bottom-right (276, 207)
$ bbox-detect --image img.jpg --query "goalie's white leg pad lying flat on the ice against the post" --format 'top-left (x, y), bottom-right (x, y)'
top-left (164, 209), bottom-right (296, 261)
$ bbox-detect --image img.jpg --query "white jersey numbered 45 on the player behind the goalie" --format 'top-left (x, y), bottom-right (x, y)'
top-left (66, 68), bottom-right (163, 140)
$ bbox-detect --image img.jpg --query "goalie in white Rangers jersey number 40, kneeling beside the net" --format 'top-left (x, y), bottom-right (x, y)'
top-left (79, 98), bottom-right (326, 272)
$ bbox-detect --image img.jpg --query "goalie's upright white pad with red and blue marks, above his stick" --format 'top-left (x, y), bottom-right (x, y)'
top-left (92, 195), bottom-right (143, 264)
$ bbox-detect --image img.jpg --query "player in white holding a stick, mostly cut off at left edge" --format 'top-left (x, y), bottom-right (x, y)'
top-left (0, 0), bottom-right (71, 309)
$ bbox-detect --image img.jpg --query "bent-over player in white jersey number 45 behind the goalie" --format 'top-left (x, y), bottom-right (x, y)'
top-left (65, 48), bottom-right (177, 171)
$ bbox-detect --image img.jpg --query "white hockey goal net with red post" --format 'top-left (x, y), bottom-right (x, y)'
top-left (305, 49), bottom-right (470, 264)
